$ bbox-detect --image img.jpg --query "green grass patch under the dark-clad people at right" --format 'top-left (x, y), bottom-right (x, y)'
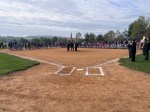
top-left (119, 53), bottom-right (150, 73)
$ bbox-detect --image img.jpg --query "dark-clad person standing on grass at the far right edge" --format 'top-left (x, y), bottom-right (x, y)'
top-left (144, 37), bottom-right (150, 61)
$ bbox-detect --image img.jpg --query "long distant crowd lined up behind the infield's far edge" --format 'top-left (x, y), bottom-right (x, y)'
top-left (0, 41), bottom-right (145, 50)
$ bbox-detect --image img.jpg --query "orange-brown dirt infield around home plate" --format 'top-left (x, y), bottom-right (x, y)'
top-left (0, 48), bottom-right (150, 112)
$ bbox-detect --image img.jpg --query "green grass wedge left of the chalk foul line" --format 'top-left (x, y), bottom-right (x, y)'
top-left (0, 53), bottom-right (39, 76)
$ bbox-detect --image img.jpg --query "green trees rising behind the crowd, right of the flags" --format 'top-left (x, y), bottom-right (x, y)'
top-left (84, 16), bottom-right (150, 43)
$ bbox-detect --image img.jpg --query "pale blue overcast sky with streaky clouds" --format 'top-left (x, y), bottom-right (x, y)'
top-left (0, 0), bottom-right (150, 37)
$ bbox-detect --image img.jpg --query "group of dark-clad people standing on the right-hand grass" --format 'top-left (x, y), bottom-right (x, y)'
top-left (128, 36), bottom-right (150, 62)
